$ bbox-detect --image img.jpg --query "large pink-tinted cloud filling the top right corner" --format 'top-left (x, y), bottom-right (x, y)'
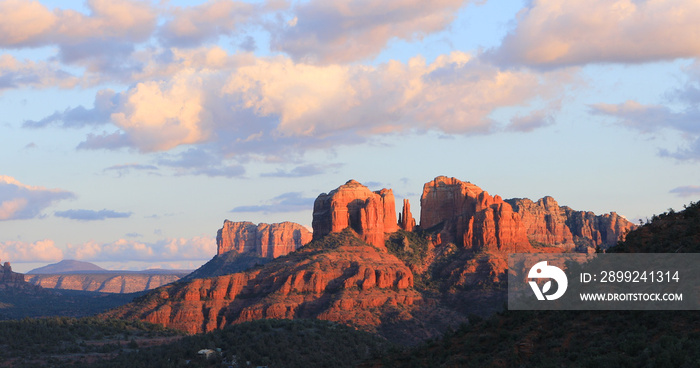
top-left (489, 0), bottom-right (700, 67)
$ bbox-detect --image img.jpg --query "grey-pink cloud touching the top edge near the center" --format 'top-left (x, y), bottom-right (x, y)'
top-left (271, 0), bottom-right (468, 63)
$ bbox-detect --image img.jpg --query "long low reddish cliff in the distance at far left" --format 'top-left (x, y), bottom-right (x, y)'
top-left (22, 272), bottom-right (185, 293)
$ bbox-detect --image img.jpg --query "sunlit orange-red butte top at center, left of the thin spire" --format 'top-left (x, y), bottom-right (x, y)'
top-left (312, 180), bottom-right (398, 249)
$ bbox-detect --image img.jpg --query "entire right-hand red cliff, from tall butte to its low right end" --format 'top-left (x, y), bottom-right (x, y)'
top-left (421, 176), bottom-right (636, 252)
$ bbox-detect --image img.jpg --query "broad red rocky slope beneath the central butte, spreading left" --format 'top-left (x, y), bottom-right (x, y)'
top-left (106, 234), bottom-right (421, 333)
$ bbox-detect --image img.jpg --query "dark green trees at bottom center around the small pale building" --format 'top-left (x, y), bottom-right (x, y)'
top-left (76, 320), bottom-right (391, 368)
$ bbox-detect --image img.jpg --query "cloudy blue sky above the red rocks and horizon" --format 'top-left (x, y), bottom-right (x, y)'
top-left (0, 0), bottom-right (700, 272)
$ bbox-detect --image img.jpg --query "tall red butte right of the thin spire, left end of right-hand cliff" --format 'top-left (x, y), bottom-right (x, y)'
top-left (420, 176), bottom-right (532, 252)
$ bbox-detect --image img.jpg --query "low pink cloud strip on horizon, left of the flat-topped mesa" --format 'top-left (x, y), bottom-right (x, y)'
top-left (65, 237), bottom-right (216, 262)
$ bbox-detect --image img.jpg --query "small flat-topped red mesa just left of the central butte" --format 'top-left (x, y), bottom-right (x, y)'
top-left (216, 220), bottom-right (312, 258)
